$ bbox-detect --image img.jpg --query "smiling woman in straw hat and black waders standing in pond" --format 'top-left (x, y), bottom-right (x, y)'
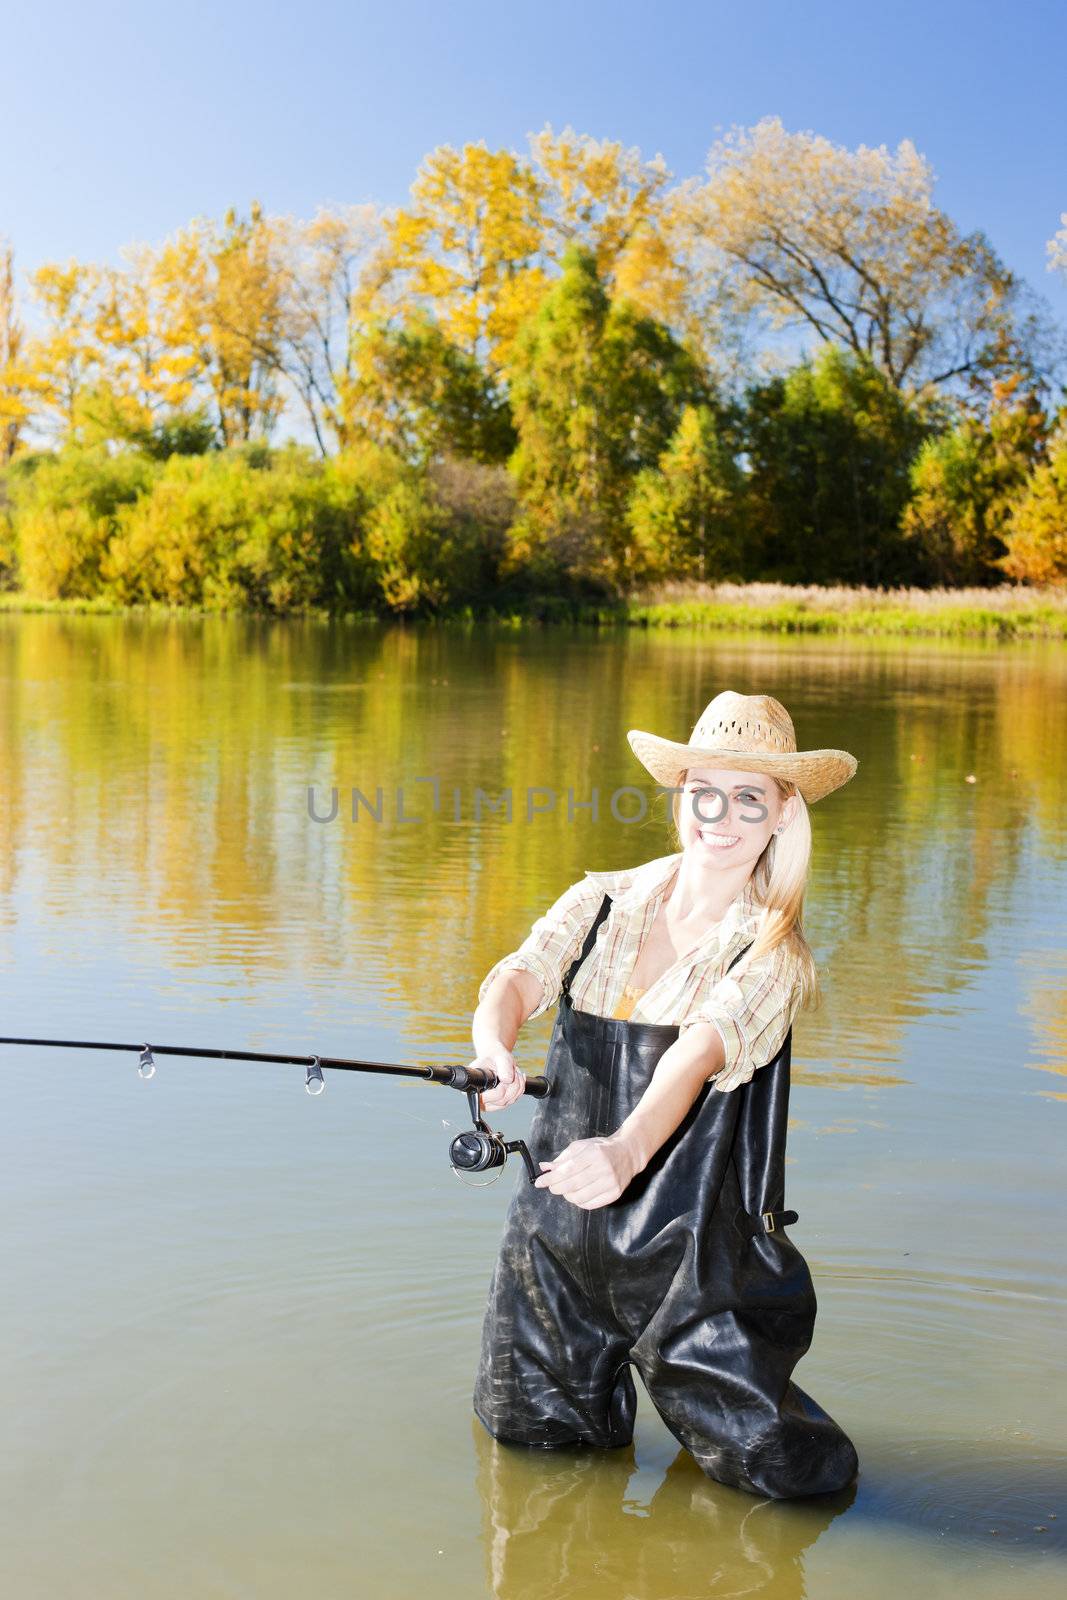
top-left (472, 690), bottom-right (857, 1498)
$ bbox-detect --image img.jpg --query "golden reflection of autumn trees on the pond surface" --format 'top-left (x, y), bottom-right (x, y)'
top-left (0, 614), bottom-right (1067, 1091)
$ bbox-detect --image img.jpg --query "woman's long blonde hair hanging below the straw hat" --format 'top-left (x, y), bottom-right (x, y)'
top-left (670, 768), bottom-right (822, 1010)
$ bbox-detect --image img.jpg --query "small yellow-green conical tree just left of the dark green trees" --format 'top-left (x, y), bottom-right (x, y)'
top-left (627, 405), bottom-right (744, 582)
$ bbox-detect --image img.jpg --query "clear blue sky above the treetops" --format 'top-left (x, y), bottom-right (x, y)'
top-left (0, 0), bottom-right (1067, 323)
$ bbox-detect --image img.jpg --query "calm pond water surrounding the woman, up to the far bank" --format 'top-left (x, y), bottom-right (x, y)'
top-left (0, 614), bottom-right (1067, 1600)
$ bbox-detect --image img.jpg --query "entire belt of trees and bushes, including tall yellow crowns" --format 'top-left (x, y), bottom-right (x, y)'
top-left (8, 137), bottom-right (1067, 598)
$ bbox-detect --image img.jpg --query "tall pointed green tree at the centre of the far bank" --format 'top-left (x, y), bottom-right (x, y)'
top-left (507, 245), bottom-right (707, 584)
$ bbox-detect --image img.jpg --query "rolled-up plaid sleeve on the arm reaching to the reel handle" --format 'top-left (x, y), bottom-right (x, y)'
top-left (680, 946), bottom-right (801, 1091)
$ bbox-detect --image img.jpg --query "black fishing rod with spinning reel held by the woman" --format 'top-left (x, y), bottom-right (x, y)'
top-left (0, 1038), bottom-right (552, 1187)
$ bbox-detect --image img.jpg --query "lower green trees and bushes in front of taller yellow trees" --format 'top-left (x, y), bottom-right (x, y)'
top-left (0, 278), bottom-right (1067, 608)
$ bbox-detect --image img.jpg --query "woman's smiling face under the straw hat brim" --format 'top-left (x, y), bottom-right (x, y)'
top-left (678, 766), bottom-right (797, 870)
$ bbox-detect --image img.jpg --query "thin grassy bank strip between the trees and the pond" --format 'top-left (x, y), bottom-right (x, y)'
top-left (0, 584), bottom-right (1067, 638)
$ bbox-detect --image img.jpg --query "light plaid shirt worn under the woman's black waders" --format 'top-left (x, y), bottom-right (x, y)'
top-left (478, 851), bottom-right (800, 1091)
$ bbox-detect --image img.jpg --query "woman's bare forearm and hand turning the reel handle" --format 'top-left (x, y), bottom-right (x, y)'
top-left (536, 1022), bottom-right (726, 1211)
